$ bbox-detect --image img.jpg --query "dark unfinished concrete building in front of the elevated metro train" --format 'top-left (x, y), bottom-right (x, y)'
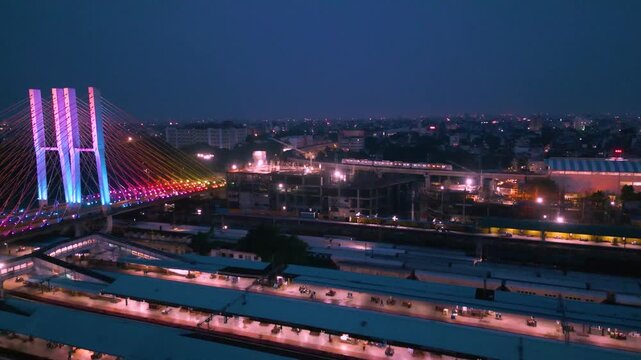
top-left (227, 164), bottom-right (423, 219)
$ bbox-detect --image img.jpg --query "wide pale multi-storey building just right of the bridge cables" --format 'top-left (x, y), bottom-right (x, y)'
top-left (165, 126), bottom-right (248, 149)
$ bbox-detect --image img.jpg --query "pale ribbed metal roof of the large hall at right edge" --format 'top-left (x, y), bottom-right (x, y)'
top-left (545, 158), bottom-right (641, 174)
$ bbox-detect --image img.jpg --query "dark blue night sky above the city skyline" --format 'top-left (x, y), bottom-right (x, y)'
top-left (0, 0), bottom-right (641, 120)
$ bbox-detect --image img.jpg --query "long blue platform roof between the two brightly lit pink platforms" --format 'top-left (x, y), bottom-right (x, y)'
top-left (97, 275), bottom-right (636, 359)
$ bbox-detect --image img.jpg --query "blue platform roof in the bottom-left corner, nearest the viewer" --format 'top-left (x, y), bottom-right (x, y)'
top-left (0, 299), bottom-right (284, 360)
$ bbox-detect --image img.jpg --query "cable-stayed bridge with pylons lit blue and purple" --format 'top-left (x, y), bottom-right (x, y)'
top-left (0, 87), bottom-right (224, 237)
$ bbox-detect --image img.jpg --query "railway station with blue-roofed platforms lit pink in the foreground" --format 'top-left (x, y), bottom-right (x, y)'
top-left (2, 235), bottom-right (641, 359)
